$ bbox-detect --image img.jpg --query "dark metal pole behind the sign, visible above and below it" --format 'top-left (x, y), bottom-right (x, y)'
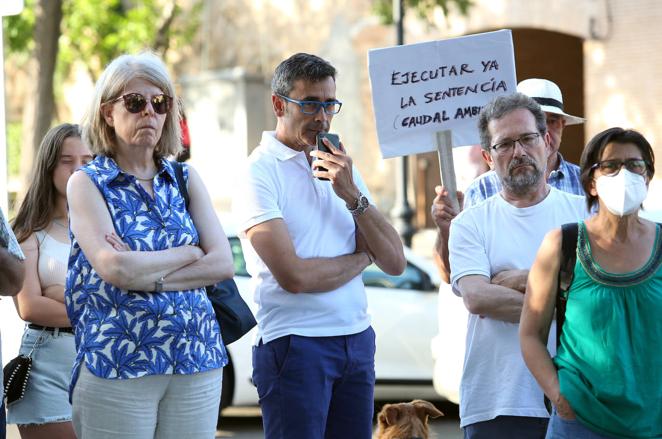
top-left (391, 0), bottom-right (415, 247)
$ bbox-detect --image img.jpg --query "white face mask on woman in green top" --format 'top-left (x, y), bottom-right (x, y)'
top-left (595, 168), bottom-right (648, 216)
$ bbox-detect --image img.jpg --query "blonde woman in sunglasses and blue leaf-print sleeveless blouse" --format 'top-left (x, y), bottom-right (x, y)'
top-left (66, 53), bottom-right (233, 439)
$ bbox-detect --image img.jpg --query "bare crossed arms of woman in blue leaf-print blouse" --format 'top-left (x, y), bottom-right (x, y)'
top-left (67, 167), bottom-right (234, 291)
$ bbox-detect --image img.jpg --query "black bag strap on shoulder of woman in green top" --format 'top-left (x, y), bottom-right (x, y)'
top-left (556, 223), bottom-right (579, 349)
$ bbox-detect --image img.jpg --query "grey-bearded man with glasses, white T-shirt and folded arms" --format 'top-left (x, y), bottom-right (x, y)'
top-left (449, 93), bottom-right (587, 439)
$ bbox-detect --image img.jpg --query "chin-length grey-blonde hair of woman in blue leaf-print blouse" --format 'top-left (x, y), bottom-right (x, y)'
top-left (82, 52), bottom-right (182, 158)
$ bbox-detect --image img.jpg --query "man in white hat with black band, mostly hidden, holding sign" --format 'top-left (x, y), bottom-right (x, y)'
top-left (431, 78), bottom-right (584, 282)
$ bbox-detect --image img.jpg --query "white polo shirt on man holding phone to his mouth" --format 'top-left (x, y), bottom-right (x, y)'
top-left (233, 132), bottom-right (370, 343)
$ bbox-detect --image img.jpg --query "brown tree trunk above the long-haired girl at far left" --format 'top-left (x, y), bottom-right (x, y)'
top-left (21, 0), bottom-right (62, 194)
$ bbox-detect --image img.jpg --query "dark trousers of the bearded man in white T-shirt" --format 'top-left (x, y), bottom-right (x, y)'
top-left (464, 416), bottom-right (548, 439)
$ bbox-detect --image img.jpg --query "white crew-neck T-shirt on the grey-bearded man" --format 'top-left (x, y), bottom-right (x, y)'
top-left (449, 188), bottom-right (588, 427)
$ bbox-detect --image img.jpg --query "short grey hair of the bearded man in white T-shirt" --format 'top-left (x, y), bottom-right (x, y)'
top-left (478, 93), bottom-right (547, 152)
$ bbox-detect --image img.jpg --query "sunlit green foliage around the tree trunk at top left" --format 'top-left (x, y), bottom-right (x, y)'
top-left (0, 0), bottom-right (201, 80)
